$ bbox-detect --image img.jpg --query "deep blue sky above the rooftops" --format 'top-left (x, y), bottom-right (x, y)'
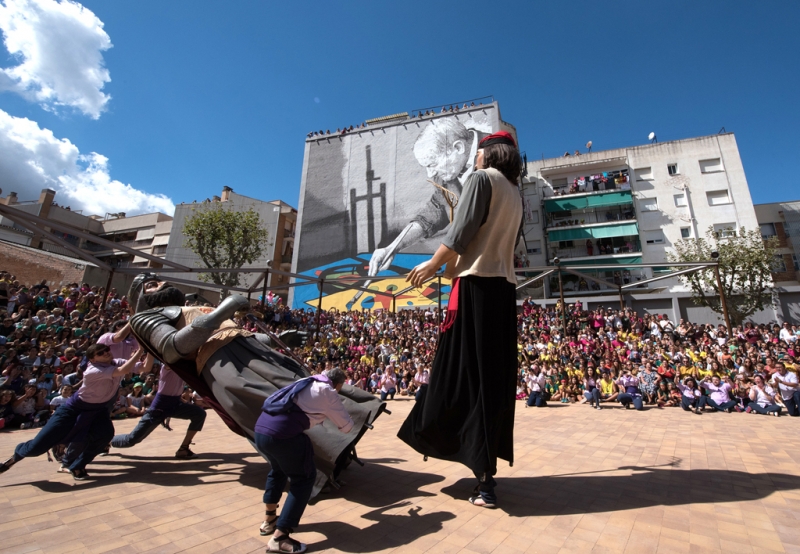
top-left (0, 0), bottom-right (800, 216)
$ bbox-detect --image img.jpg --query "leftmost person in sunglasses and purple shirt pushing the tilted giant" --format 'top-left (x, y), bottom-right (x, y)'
top-left (0, 344), bottom-right (153, 481)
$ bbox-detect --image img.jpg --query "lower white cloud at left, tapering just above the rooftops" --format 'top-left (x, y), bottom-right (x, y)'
top-left (0, 110), bottom-right (175, 215)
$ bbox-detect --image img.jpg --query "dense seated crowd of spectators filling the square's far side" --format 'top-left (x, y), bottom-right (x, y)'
top-left (0, 271), bottom-right (800, 436)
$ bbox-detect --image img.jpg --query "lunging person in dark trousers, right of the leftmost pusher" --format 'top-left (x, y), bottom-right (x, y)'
top-left (111, 364), bottom-right (206, 459)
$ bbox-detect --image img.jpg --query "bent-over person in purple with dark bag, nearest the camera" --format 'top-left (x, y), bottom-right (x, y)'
top-left (255, 368), bottom-right (354, 554)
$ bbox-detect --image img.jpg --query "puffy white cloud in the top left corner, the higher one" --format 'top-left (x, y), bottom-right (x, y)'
top-left (0, 0), bottom-right (111, 119)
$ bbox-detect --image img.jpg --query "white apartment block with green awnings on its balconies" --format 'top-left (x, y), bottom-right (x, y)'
top-left (523, 133), bottom-right (776, 322)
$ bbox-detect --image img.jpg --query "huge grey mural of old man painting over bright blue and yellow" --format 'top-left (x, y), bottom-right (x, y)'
top-left (292, 103), bottom-right (500, 309)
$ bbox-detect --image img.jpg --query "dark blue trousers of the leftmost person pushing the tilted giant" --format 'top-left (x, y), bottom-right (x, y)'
top-left (14, 404), bottom-right (114, 471)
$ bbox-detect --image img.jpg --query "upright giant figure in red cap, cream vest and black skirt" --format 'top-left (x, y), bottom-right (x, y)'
top-left (398, 131), bottom-right (523, 508)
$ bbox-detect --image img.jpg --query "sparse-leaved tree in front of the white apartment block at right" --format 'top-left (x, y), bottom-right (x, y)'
top-left (667, 227), bottom-right (778, 326)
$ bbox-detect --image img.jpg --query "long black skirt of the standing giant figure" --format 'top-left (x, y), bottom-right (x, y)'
top-left (397, 276), bottom-right (517, 475)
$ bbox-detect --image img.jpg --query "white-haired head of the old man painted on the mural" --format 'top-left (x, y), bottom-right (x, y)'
top-left (414, 117), bottom-right (472, 182)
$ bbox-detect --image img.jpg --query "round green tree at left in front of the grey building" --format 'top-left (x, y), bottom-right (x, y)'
top-left (183, 202), bottom-right (268, 287)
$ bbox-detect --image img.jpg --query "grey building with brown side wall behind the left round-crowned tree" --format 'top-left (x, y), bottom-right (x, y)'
top-left (165, 186), bottom-right (297, 299)
